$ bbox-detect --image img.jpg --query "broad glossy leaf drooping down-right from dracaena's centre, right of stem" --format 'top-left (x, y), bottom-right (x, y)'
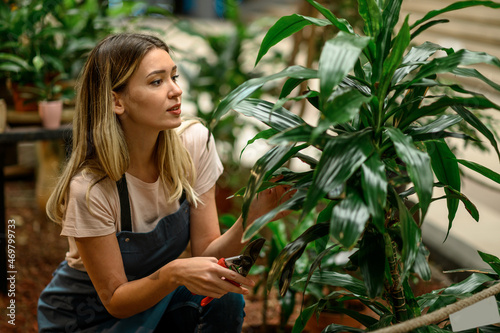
top-left (386, 128), bottom-right (434, 221)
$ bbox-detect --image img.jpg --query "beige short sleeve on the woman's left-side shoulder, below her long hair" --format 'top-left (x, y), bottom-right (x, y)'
top-left (61, 174), bottom-right (119, 238)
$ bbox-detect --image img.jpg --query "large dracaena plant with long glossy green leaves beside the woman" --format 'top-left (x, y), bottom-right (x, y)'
top-left (208, 0), bottom-right (500, 332)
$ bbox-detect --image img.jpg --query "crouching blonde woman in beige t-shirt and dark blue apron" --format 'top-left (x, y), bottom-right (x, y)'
top-left (38, 34), bottom-right (286, 332)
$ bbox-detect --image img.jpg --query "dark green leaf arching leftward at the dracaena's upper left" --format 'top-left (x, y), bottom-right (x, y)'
top-left (255, 14), bottom-right (331, 65)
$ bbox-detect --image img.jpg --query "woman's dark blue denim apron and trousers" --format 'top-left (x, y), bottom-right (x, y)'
top-left (38, 182), bottom-right (245, 333)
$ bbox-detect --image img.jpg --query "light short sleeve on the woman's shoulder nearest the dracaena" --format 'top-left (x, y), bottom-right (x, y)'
top-left (181, 123), bottom-right (224, 195)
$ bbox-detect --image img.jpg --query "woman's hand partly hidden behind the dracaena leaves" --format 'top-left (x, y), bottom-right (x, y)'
top-left (248, 185), bottom-right (296, 222)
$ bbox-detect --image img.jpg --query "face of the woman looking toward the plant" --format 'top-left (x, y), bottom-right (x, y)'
top-left (113, 49), bottom-right (182, 134)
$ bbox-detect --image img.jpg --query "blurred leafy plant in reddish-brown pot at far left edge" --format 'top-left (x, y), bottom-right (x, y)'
top-left (0, 0), bottom-right (65, 111)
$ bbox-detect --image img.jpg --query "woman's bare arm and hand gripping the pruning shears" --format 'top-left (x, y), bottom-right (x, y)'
top-left (76, 234), bottom-right (253, 318)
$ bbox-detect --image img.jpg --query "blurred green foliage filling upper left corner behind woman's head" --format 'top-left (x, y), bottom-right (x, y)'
top-left (0, 0), bottom-right (169, 100)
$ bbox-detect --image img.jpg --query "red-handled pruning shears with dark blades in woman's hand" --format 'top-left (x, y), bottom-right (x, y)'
top-left (201, 238), bottom-right (266, 306)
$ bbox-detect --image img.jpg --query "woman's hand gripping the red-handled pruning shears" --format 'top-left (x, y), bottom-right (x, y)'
top-left (172, 257), bottom-right (255, 298)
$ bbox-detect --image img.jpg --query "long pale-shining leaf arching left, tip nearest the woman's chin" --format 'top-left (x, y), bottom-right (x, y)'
top-left (209, 66), bottom-right (318, 128)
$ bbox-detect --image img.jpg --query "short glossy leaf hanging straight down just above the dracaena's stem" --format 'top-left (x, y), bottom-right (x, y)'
top-left (361, 154), bottom-right (387, 232)
